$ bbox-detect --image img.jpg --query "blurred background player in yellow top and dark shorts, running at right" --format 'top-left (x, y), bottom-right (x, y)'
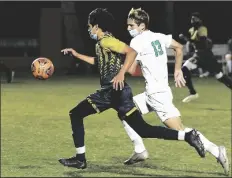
top-left (180, 12), bottom-right (232, 103)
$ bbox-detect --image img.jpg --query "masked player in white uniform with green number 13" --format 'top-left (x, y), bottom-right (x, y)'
top-left (122, 8), bottom-right (229, 175)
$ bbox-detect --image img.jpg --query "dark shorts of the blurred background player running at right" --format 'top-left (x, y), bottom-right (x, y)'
top-left (190, 50), bottom-right (222, 74)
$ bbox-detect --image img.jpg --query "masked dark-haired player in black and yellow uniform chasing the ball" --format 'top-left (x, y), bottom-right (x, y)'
top-left (59, 8), bottom-right (205, 169)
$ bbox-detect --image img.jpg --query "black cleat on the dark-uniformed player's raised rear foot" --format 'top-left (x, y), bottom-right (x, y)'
top-left (185, 129), bottom-right (205, 158)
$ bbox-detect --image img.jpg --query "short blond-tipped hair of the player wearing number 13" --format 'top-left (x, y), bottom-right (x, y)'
top-left (128, 8), bottom-right (149, 28)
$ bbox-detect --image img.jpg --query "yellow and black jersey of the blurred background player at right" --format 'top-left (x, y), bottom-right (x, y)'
top-left (189, 25), bottom-right (212, 50)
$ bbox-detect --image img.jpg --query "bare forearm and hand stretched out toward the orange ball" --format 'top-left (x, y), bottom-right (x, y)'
top-left (61, 48), bottom-right (95, 65)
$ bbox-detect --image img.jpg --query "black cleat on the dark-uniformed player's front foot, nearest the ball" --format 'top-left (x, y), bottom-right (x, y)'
top-left (59, 156), bottom-right (87, 169)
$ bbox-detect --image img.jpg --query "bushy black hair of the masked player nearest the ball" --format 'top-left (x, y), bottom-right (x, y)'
top-left (88, 8), bottom-right (114, 32)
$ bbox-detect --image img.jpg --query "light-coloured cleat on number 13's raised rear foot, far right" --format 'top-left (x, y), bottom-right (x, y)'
top-left (217, 146), bottom-right (229, 176)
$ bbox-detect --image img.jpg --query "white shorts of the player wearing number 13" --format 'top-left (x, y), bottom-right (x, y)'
top-left (133, 89), bottom-right (181, 122)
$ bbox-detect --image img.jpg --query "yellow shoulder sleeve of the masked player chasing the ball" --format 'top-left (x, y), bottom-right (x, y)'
top-left (100, 37), bottom-right (126, 53)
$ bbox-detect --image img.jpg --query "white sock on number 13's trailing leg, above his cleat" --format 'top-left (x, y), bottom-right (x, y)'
top-left (197, 131), bottom-right (219, 158)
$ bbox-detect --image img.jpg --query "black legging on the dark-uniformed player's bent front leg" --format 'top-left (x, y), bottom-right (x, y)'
top-left (69, 100), bottom-right (96, 161)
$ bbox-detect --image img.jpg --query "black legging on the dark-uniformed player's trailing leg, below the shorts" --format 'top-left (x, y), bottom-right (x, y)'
top-left (123, 110), bottom-right (178, 140)
